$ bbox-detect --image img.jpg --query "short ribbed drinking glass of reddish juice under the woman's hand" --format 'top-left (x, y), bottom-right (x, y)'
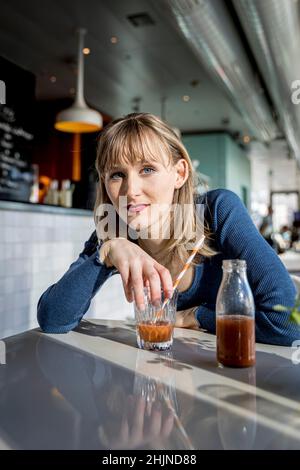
top-left (134, 287), bottom-right (178, 350)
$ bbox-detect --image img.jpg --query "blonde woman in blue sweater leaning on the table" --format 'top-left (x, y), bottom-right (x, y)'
top-left (38, 113), bottom-right (299, 345)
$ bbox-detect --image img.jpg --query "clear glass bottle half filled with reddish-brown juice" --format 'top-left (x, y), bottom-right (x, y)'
top-left (216, 259), bottom-right (255, 367)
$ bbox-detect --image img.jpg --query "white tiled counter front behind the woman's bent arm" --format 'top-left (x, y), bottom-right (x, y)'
top-left (0, 209), bottom-right (132, 338)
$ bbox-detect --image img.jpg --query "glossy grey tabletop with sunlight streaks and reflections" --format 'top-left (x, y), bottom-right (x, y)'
top-left (0, 320), bottom-right (300, 449)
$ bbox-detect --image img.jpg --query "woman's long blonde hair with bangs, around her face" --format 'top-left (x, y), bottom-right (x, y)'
top-left (94, 113), bottom-right (216, 264)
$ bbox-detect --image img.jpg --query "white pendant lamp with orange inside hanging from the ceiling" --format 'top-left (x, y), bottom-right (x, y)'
top-left (54, 28), bottom-right (103, 134)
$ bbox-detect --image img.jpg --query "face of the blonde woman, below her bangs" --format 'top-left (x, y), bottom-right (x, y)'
top-left (105, 151), bottom-right (188, 231)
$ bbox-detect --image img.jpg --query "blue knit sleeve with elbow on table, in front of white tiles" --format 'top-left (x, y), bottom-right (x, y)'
top-left (37, 232), bottom-right (115, 333)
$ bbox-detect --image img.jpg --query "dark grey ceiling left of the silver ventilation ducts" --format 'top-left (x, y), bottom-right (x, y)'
top-left (0, 0), bottom-right (255, 134)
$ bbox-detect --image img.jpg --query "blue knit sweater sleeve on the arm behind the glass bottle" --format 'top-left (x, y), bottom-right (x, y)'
top-left (196, 189), bottom-right (300, 346)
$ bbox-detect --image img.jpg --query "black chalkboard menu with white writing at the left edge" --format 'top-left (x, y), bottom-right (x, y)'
top-left (0, 58), bottom-right (35, 201)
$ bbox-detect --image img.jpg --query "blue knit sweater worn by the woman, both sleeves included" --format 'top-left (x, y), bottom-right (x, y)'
top-left (38, 189), bottom-right (300, 346)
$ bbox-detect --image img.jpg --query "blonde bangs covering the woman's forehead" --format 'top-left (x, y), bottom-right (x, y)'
top-left (98, 123), bottom-right (172, 176)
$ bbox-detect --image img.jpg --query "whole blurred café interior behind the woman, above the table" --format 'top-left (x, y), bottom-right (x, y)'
top-left (0, 0), bottom-right (300, 337)
